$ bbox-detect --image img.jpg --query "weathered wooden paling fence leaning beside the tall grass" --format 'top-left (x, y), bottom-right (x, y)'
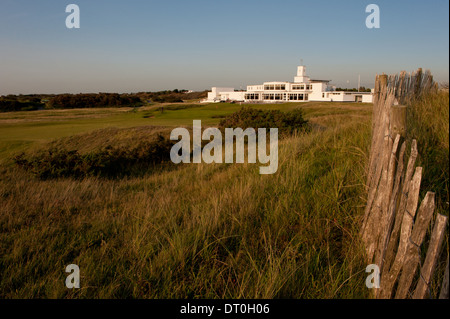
top-left (360, 69), bottom-right (442, 298)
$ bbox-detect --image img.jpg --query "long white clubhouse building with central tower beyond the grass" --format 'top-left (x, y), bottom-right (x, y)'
top-left (202, 65), bottom-right (373, 103)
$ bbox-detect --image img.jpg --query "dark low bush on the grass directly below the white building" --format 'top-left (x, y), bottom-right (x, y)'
top-left (219, 107), bottom-right (308, 136)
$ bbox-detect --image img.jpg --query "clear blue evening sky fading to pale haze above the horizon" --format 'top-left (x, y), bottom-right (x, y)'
top-left (0, 0), bottom-right (449, 95)
